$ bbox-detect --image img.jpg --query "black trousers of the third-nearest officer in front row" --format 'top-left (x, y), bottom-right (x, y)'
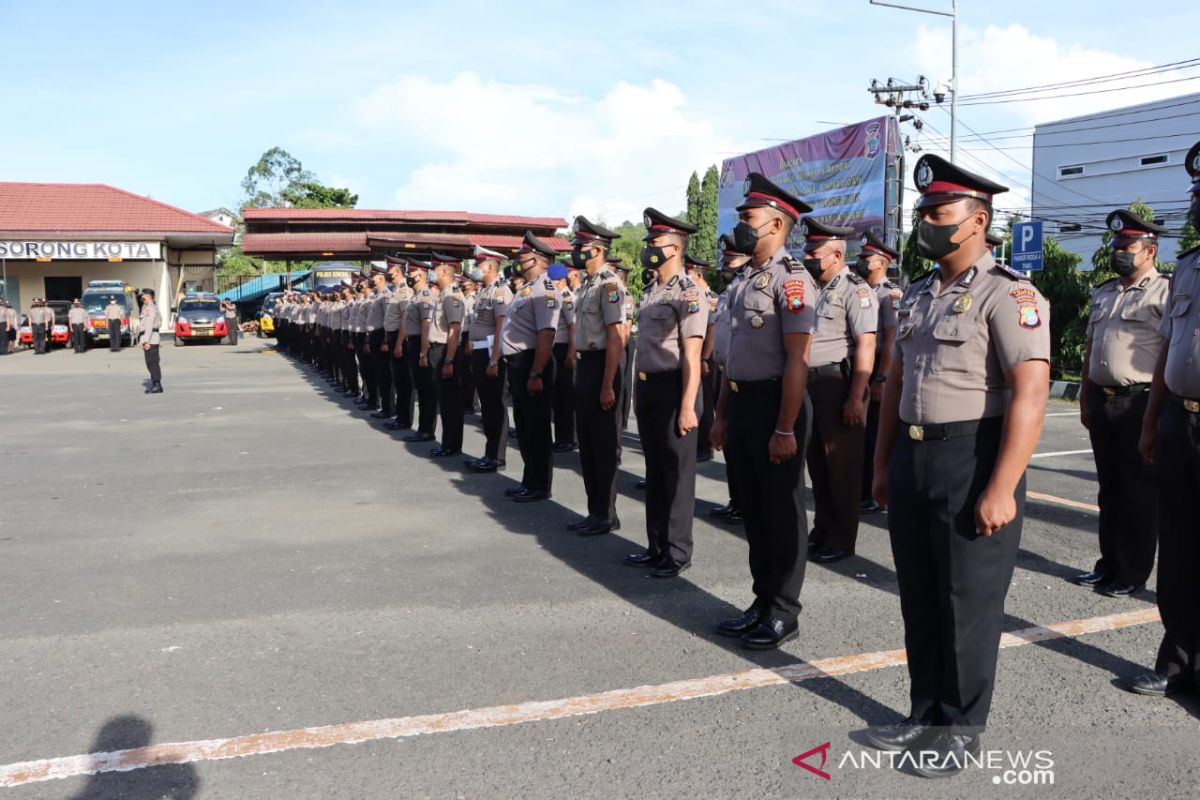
top-left (634, 369), bottom-right (701, 564)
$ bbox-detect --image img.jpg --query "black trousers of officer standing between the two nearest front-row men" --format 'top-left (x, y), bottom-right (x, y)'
top-left (808, 378), bottom-right (865, 553)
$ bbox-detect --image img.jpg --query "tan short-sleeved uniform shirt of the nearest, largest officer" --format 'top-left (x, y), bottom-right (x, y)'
top-left (895, 253), bottom-right (1050, 425)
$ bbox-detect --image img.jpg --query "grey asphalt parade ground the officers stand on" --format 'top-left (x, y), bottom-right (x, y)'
top-left (0, 338), bottom-right (1200, 800)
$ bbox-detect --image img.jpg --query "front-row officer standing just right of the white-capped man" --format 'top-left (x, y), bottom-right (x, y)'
top-left (500, 230), bottom-right (562, 503)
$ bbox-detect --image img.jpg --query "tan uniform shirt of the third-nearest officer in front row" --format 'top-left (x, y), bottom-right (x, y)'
top-left (634, 275), bottom-right (708, 373)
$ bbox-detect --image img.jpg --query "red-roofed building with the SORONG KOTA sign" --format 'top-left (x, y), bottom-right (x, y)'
top-left (0, 182), bottom-right (234, 309)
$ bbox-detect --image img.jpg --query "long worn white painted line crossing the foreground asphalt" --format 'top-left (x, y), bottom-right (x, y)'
top-left (0, 608), bottom-right (1159, 788)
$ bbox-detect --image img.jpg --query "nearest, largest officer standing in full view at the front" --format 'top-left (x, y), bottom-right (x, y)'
top-left (868, 155), bottom-right (1050, 777)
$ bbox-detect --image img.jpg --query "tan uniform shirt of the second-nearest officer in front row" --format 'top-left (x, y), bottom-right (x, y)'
top-left (725, 247), bottom-right (817, 380)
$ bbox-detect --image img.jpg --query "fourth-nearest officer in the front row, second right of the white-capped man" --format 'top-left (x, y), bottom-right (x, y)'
top-left (568, 217), bottom-right (626, 536)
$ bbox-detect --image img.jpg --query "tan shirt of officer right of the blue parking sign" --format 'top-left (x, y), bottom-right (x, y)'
top-left (1087, 270), bottom-right (1171, 386)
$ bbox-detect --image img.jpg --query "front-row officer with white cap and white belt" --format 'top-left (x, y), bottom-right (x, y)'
top-left (467, 247), bottom-right (512, 473)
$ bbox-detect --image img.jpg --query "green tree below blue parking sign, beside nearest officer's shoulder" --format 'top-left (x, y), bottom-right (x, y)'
top-left (1027, 236), bottom-right (1092, 379)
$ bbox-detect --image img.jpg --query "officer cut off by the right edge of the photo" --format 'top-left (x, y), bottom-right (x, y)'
top-left (1126, 142), bottom-right (1200, 697)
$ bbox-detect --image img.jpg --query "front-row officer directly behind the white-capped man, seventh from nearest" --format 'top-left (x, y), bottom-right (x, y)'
top-left (427, 255), bottom-right (466, 458)
